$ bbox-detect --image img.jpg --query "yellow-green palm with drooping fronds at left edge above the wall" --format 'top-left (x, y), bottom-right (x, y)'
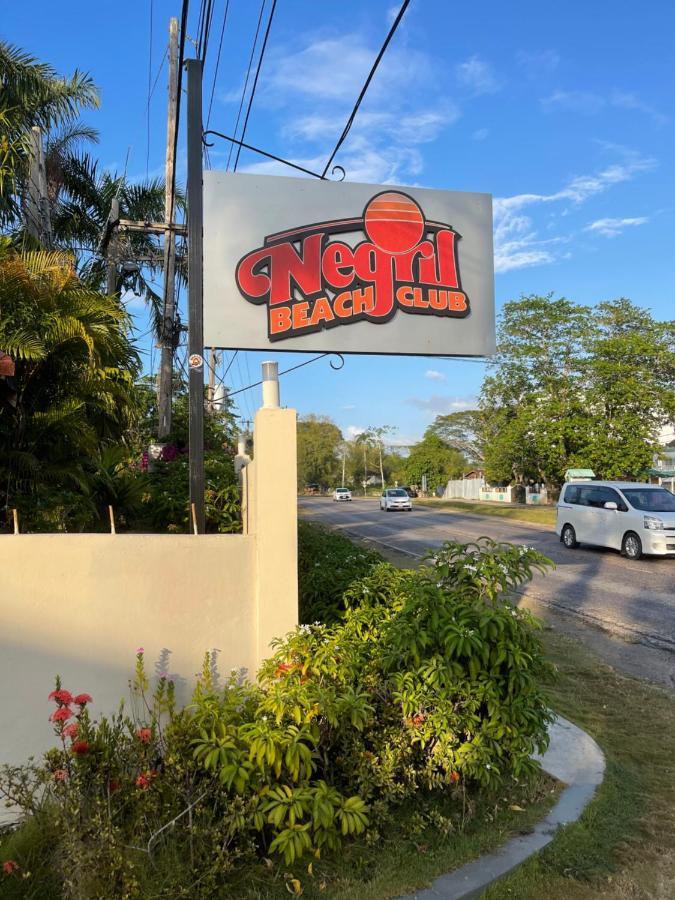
top-left (0, 238), bottom-right (139, 528)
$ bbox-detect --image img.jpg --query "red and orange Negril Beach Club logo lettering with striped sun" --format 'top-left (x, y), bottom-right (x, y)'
top-left (236, 191), bottom-right (470, 341)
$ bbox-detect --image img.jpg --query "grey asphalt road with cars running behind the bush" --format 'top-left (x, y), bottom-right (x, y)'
top-left (299, 497), bottom-right (675, 687)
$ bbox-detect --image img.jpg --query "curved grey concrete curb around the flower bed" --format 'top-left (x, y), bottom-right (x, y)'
top-left (400, 717), bottom-right (605, 900)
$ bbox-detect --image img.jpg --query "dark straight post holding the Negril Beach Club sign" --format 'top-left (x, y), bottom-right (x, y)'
top-left (186, 59), bottom-right (205, 534)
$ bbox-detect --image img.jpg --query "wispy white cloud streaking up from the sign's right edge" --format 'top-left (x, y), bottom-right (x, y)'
top-left (493, 148), bottom-right (656, 272)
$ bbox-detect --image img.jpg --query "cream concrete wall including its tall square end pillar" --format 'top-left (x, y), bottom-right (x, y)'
top-left (0, 409), bottom-right (298, 763)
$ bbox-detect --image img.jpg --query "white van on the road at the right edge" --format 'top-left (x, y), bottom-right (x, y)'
top-left (555, 481), bottom-right (675, 559)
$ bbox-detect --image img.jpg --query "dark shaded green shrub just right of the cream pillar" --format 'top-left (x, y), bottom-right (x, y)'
top-left (298, 522), bottom-right (384, 624)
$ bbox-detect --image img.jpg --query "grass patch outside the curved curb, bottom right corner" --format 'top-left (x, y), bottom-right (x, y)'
top-left (484, 632), bottom-right (675, 900)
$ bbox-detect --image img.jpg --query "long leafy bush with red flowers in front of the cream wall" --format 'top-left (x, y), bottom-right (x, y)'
top-left (0, 535), bottom-right (552, 900)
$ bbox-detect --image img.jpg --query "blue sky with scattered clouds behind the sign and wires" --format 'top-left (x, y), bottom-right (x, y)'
top-left (0, 0), bottom-right (675, 443)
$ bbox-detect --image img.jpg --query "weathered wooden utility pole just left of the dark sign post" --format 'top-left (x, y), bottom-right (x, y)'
top-left (157, 18), bottom-right (178, 440)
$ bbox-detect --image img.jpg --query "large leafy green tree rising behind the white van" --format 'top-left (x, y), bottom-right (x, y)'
top-left (480, 295), bottom-right (675, 486)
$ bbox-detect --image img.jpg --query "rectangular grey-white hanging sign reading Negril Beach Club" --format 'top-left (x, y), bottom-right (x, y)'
top-left (204, 171), bottom-right (495, 356)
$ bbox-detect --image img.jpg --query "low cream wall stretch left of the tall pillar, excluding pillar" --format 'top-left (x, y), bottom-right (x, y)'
top-left (0, 534), bottom-right (258, 762)
